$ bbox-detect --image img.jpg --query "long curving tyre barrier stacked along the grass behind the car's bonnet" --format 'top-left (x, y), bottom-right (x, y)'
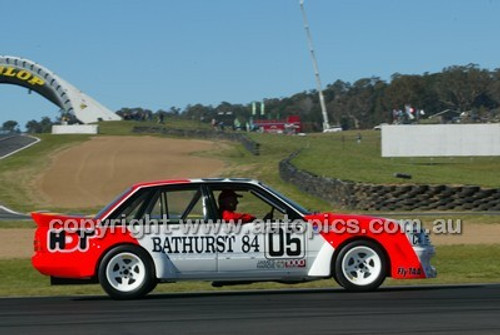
top-left (279, 152), bottom-right (500, 211)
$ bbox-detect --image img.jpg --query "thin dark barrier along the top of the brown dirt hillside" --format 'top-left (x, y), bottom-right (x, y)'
top-left (132, 127), bottom-right (260, 156)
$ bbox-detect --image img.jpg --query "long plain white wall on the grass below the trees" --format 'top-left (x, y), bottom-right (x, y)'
top-left (382, 123), bottom-right (500, 157)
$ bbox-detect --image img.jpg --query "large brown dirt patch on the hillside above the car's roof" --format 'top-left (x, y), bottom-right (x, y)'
top-left (35, 136), bottom-right (225, 209)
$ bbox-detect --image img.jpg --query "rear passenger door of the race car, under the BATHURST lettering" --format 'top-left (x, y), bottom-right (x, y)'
top-left (134, 184), bottom-right (217, 279)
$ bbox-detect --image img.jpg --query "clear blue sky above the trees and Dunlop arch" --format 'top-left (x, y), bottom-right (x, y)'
top-left (0, 0), bottom-right (500, 129)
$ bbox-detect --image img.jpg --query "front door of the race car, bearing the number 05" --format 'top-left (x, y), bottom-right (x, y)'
top-left (210, 184), bottom-right (306, 279)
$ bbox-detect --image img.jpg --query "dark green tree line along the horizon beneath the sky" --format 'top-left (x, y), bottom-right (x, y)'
top-left (3, 64), bottom-right (500, 133)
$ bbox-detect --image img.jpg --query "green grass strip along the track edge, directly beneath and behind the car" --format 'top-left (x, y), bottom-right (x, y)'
top-left (0, 244), bottom-right (500, 297)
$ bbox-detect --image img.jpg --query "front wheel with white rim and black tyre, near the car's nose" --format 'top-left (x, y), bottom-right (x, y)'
top-left (333, 240), bottom-right (387, 292)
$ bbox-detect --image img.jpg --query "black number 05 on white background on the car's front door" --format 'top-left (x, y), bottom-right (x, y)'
top-left (265, 226), bottom-right (305, 258)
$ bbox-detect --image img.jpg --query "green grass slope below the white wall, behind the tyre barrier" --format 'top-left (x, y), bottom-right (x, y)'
top-left (293, 130), bottom-right (500, 188)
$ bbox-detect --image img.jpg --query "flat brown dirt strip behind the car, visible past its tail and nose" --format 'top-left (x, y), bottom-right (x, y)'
top-left (0, 223), bottom-right (500, 259)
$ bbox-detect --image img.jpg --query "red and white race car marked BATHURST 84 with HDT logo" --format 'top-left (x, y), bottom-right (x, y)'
top-left (32, 178), bottom-right (436, 299)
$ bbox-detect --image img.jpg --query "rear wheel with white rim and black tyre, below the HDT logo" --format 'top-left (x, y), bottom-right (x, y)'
top-left (98, 245), bottom-right (157, 300)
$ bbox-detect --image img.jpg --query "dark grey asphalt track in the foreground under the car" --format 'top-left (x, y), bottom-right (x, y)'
top-left (0, 284), bottom-right (500, 335)
